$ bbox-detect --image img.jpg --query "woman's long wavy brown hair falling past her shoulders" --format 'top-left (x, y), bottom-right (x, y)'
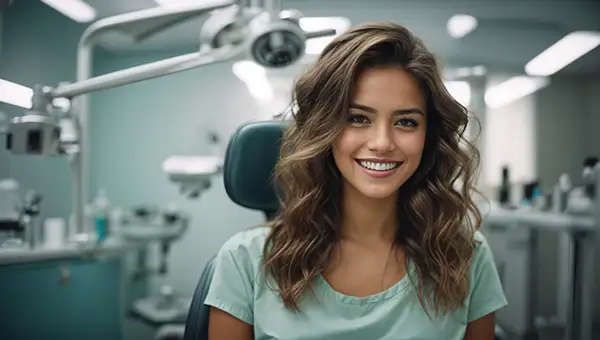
top-left (263, 23), bottom-right (481, 314)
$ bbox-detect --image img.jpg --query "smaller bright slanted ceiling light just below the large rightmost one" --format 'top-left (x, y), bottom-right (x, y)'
top-left (485, 76), bottom-right (550, 108)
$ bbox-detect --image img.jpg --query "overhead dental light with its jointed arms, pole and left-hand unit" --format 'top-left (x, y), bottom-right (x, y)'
top-left (6, 0), bottom-right (335, 236)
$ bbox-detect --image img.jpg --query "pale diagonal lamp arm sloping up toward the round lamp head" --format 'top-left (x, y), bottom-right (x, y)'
top-left (50, 46), bottom-right (242, 98)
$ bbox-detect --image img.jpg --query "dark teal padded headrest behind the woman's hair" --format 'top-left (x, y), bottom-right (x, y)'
top-left (223, 121), bottom-right (288, 214)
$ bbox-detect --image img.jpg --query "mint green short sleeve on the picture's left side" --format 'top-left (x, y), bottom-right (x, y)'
top-left (204, 238), bottom-right (254, 325)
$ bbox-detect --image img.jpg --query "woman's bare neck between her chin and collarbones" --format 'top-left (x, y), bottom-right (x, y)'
top-left (341, 185), bottom-right (397, 244)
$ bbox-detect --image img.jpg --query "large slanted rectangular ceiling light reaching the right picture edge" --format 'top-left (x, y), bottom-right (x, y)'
top-left (525, 31), bottom-right (600, 76)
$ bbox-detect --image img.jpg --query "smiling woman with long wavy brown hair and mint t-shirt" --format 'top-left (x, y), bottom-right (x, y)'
top-left (205, 23), bottom-right (506, 340)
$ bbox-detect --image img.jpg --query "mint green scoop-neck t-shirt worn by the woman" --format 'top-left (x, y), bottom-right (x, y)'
top-left (205, 228), bottom-right (507, 340)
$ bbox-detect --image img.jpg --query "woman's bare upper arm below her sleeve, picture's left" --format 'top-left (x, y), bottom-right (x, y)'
top-left (208, 307), bottom-right (253, 340)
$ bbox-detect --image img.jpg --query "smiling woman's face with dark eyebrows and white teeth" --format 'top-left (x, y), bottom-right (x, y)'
top-left (333, 67), bottom-right (427, 199)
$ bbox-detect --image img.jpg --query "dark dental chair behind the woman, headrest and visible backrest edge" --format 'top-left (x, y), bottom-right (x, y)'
top-left (183, 121), bottom-right (287, 340)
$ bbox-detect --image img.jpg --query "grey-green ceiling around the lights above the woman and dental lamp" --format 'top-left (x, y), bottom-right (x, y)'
top-left (44, 0), bottom-right (600, 74)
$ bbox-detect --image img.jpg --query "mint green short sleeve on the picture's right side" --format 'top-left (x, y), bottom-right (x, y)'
top-left (468, 232), bottom-right (508, 322)
